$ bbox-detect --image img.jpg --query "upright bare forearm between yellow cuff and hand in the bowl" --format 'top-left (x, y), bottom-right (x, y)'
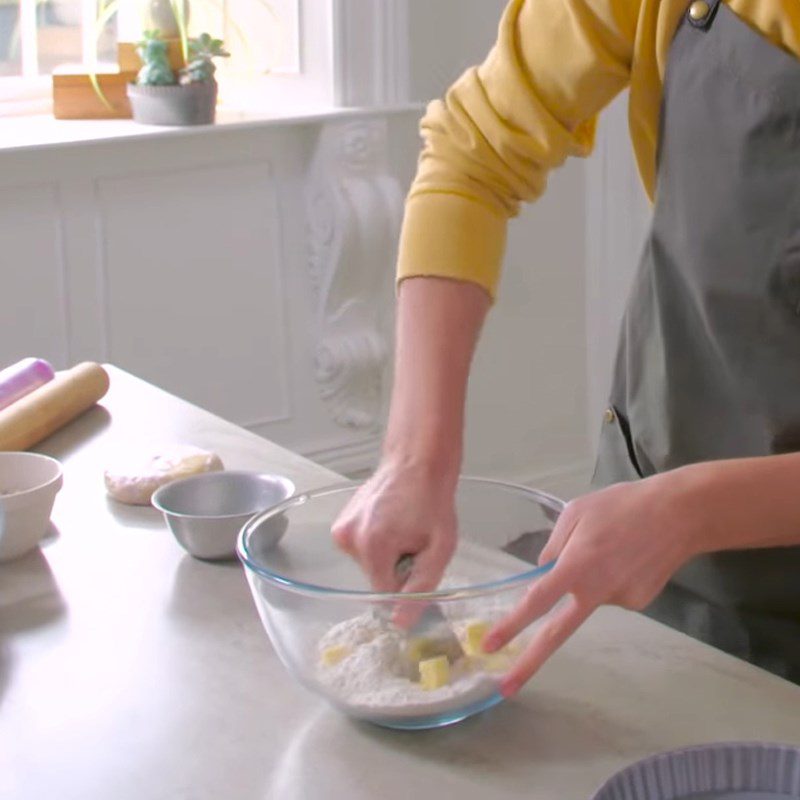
top-left (385, 278), bottom-right (491, 475)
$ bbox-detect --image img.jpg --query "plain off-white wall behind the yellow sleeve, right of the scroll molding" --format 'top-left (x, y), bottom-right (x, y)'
top-left (409, 0), bottom-right (591, 495)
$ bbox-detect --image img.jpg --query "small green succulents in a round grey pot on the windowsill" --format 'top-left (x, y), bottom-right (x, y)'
top-left (128, 31), bottom-right (229, 125)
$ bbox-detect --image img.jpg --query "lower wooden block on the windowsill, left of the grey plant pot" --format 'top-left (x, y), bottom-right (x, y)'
top-left (53, 72), bottom-right (136, 119)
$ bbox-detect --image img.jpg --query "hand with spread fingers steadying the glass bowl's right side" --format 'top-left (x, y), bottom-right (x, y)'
top-left (484, 470), bottom-right (702, 696)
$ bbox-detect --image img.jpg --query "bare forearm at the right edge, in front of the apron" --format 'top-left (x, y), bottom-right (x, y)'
top-left (675, 453), bottom-right (800, 553)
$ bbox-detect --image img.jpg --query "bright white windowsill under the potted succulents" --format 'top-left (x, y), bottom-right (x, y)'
top-left (0, 103), bottom-right (423, 152)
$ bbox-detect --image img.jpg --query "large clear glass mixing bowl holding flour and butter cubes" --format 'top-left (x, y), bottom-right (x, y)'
top-left (237, 478), bottom-right (564, 729)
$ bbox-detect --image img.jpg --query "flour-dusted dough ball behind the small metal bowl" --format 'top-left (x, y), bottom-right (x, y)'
top-left (104, 445), bottom-right (224, 506)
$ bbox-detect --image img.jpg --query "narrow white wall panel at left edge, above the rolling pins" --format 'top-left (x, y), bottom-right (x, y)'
top-left (0, 184), bottom-right (69, 366)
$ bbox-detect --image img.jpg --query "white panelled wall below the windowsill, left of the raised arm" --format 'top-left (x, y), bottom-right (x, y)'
top-left (0, 109), bottom-right (418, 470)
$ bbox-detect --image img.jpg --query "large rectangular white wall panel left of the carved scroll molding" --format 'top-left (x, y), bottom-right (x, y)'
top-left (97, 161), bottom-right (290, 425)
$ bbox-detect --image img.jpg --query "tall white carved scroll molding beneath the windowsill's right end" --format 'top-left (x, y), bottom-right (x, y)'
top-left (306, 119), bottom-right (403, 429)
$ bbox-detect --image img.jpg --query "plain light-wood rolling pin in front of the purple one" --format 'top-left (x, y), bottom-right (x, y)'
top-left (0, 361), bottom-right (109, 450)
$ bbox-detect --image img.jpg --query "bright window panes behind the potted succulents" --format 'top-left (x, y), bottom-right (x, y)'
top-left (0, 0), bottom-right (306, 116)
